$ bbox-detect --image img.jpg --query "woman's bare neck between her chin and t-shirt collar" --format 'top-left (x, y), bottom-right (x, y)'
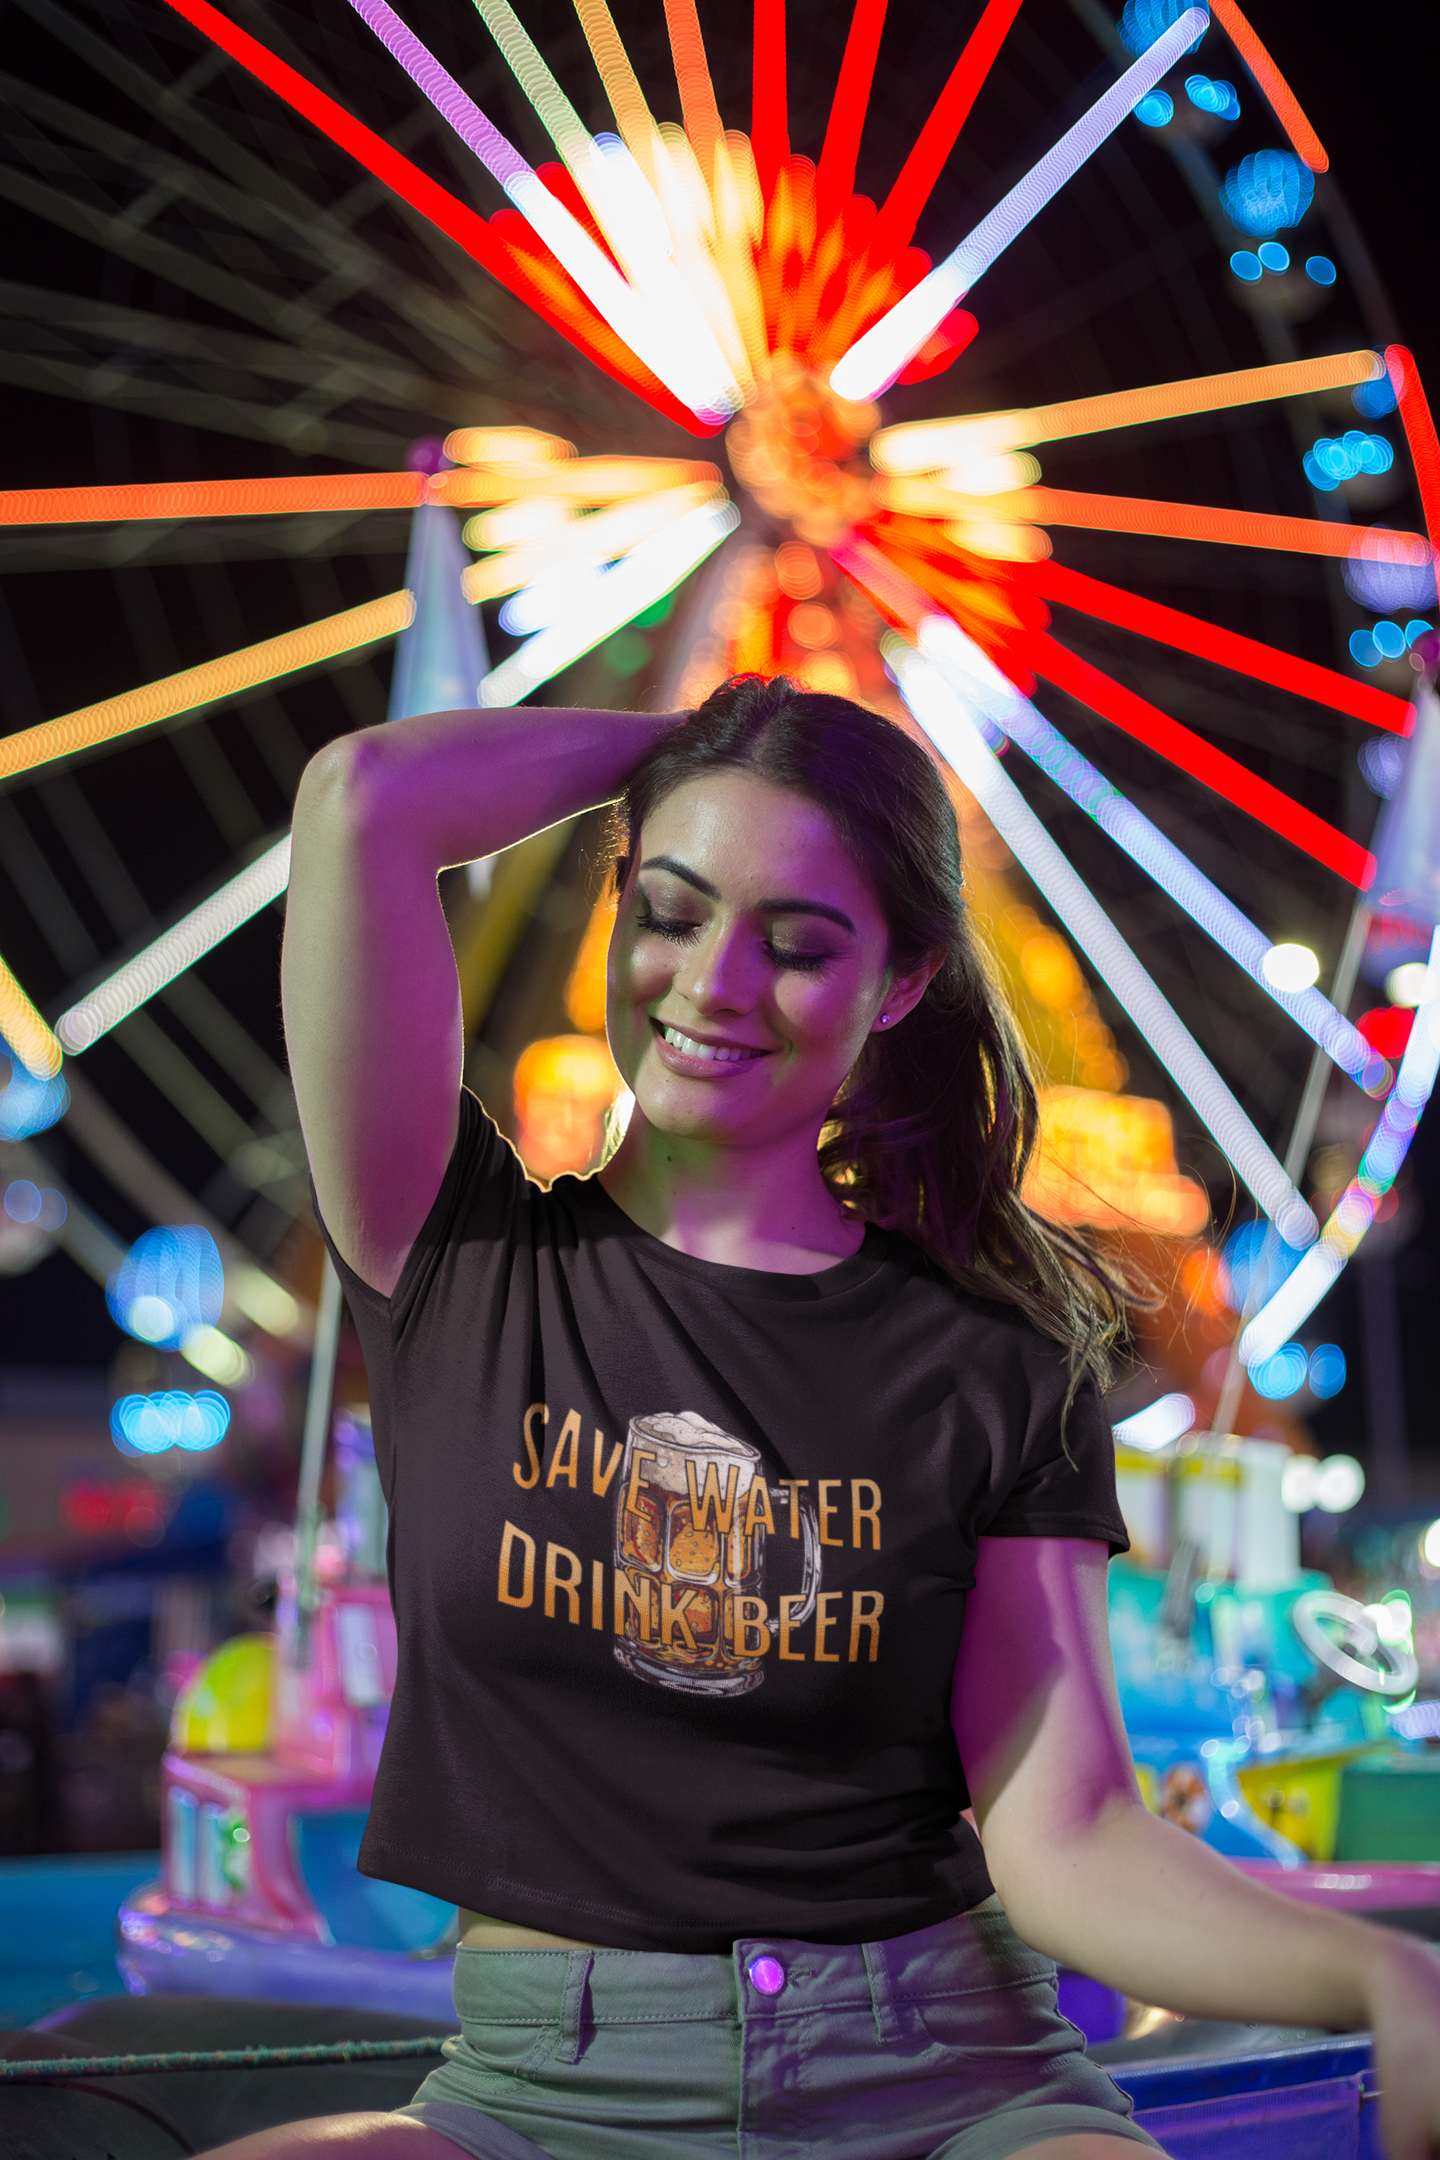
top-left (600, 1110), bottom-right (864, 1274)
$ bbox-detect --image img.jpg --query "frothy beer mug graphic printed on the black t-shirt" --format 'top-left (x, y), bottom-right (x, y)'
top-left (615, 1410), bottom-right (820, 1696)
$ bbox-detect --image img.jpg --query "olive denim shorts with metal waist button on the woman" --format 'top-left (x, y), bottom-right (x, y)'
top-left (399, 1899), bottom-right (1159, 2160)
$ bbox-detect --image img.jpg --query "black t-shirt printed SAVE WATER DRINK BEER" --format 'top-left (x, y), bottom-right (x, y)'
top-left (341, 1093), bottom-right (1125, 1953)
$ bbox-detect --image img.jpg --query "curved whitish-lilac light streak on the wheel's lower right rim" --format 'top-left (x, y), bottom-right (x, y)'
top-left (1239, 931), bottom-right (1440, 1365)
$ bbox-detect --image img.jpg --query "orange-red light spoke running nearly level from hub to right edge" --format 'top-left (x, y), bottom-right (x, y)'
top-left (872, 475), bottom-right (1431, 568)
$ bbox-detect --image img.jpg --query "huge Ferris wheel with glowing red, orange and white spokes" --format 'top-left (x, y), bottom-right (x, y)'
top-left (0, 0), bottom-right (1440, 1434)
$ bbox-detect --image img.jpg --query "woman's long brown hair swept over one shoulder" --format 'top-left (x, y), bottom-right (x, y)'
top-left (615, 676), bottom-right (1127, 1385)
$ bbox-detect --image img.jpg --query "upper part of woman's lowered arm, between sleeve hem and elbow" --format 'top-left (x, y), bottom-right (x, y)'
top-left (952, 1538), bottom-right (1136, 1894)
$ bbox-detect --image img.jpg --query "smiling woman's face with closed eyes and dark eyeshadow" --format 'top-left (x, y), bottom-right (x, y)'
top-left (607, 771), bottom-right (928, 1147)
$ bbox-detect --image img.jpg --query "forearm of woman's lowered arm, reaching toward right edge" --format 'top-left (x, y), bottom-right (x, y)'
top-left (987, 1797), bottom-right (1440, 2033)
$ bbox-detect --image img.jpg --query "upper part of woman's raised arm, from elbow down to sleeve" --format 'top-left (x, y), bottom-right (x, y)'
top-left (283, 734), bottom-right (464, 1294)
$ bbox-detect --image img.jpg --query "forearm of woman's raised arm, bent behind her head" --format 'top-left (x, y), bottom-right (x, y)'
top-left (296, 706), bottom-right (682, 870)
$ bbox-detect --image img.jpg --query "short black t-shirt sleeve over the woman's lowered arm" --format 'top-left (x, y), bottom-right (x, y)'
top-left (976, 1361), bottom-right (1129, 1555)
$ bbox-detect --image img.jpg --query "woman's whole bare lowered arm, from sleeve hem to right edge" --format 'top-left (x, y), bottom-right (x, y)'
top-left (952, 1538), bottom-right (1440, 2160)
